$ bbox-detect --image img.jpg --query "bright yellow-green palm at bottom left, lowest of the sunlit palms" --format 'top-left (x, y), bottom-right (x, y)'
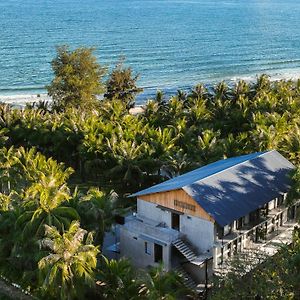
top-left (38, 221), bottom-right (99, 300)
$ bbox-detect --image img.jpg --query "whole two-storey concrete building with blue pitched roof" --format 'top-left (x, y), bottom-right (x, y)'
top-left (120, 150), bottom-right (299, 290)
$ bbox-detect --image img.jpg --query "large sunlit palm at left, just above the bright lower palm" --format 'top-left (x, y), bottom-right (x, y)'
top-left (10, 148), bottom-right (79, 239)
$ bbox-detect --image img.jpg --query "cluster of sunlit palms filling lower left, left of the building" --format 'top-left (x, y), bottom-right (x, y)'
top-left (0, 147), bottom-right (107, 299)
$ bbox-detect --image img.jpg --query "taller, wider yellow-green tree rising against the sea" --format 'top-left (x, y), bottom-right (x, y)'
top-left (47, 46), bottom-right (105, 110)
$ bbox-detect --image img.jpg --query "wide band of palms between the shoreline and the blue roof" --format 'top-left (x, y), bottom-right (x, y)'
top-left (0, 73), bottom-right (300, 197)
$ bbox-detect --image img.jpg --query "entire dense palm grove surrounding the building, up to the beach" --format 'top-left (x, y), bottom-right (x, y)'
top-left (0, 48), bottom-right (300, 299)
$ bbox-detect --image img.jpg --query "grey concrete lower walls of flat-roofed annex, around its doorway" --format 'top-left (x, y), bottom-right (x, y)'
top-left (120, 226), bottom-right (171, 271)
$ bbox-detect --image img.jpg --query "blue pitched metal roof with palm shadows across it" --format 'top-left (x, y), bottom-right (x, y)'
top-left (132, 150), bottom-right (294, 226)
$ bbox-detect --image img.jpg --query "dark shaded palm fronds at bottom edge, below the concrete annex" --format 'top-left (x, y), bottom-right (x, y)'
top-left (97, 258), bottom-right (195, 300)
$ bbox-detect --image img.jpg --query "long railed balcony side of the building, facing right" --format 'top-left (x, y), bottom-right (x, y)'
top-left (213, 201), bottom-right (300, 273)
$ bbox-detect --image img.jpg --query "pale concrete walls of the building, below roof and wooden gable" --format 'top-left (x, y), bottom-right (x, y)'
top-left (120, 195), bottom-right (298, 279)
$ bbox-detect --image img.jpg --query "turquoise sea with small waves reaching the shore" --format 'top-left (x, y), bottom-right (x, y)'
top-left (0, 0), bottom-right (300, 103)
